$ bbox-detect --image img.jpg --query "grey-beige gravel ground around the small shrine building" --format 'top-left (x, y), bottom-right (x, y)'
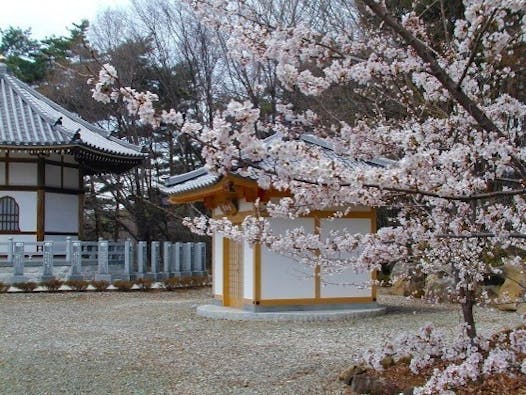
top-left (0, 289), bottom-right (519, 395)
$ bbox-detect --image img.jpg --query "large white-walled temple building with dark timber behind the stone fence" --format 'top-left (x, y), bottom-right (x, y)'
top-left (0, 58), bottom-right (145, 242)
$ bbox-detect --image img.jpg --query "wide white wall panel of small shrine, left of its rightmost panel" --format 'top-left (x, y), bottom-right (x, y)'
top-left (261, 218), bottom-right (315, 299)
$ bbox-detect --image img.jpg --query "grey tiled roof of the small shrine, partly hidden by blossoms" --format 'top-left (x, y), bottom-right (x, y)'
top-left (161, 134), bottom-right (394, 202)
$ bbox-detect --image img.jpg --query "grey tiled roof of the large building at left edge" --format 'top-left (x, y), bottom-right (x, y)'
top-left (0, 60), bottom-right (146, 172)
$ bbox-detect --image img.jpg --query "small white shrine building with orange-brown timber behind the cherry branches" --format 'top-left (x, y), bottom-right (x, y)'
top-left (164, 136), bottom-right (382, 312)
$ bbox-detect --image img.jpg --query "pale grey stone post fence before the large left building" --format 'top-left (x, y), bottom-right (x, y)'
top-left (0, 238), bottom-right (207, 284)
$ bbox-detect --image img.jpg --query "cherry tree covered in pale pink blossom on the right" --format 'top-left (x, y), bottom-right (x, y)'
top-left (88, 0), bottom-right (526, 393)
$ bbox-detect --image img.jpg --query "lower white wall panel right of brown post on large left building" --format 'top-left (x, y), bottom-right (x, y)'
top-left (45, 193), bottom-right (79, 233)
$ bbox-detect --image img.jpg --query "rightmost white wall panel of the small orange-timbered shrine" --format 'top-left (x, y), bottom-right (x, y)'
top-left (320, 218), bottom-right (372, 298)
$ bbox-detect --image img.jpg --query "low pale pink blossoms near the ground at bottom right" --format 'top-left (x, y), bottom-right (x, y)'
top-left (355, 323), bottom-right (526, 394)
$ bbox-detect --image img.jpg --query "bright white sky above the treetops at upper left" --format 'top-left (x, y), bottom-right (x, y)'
top-left (0, 0), bottom-right (129, 39)
